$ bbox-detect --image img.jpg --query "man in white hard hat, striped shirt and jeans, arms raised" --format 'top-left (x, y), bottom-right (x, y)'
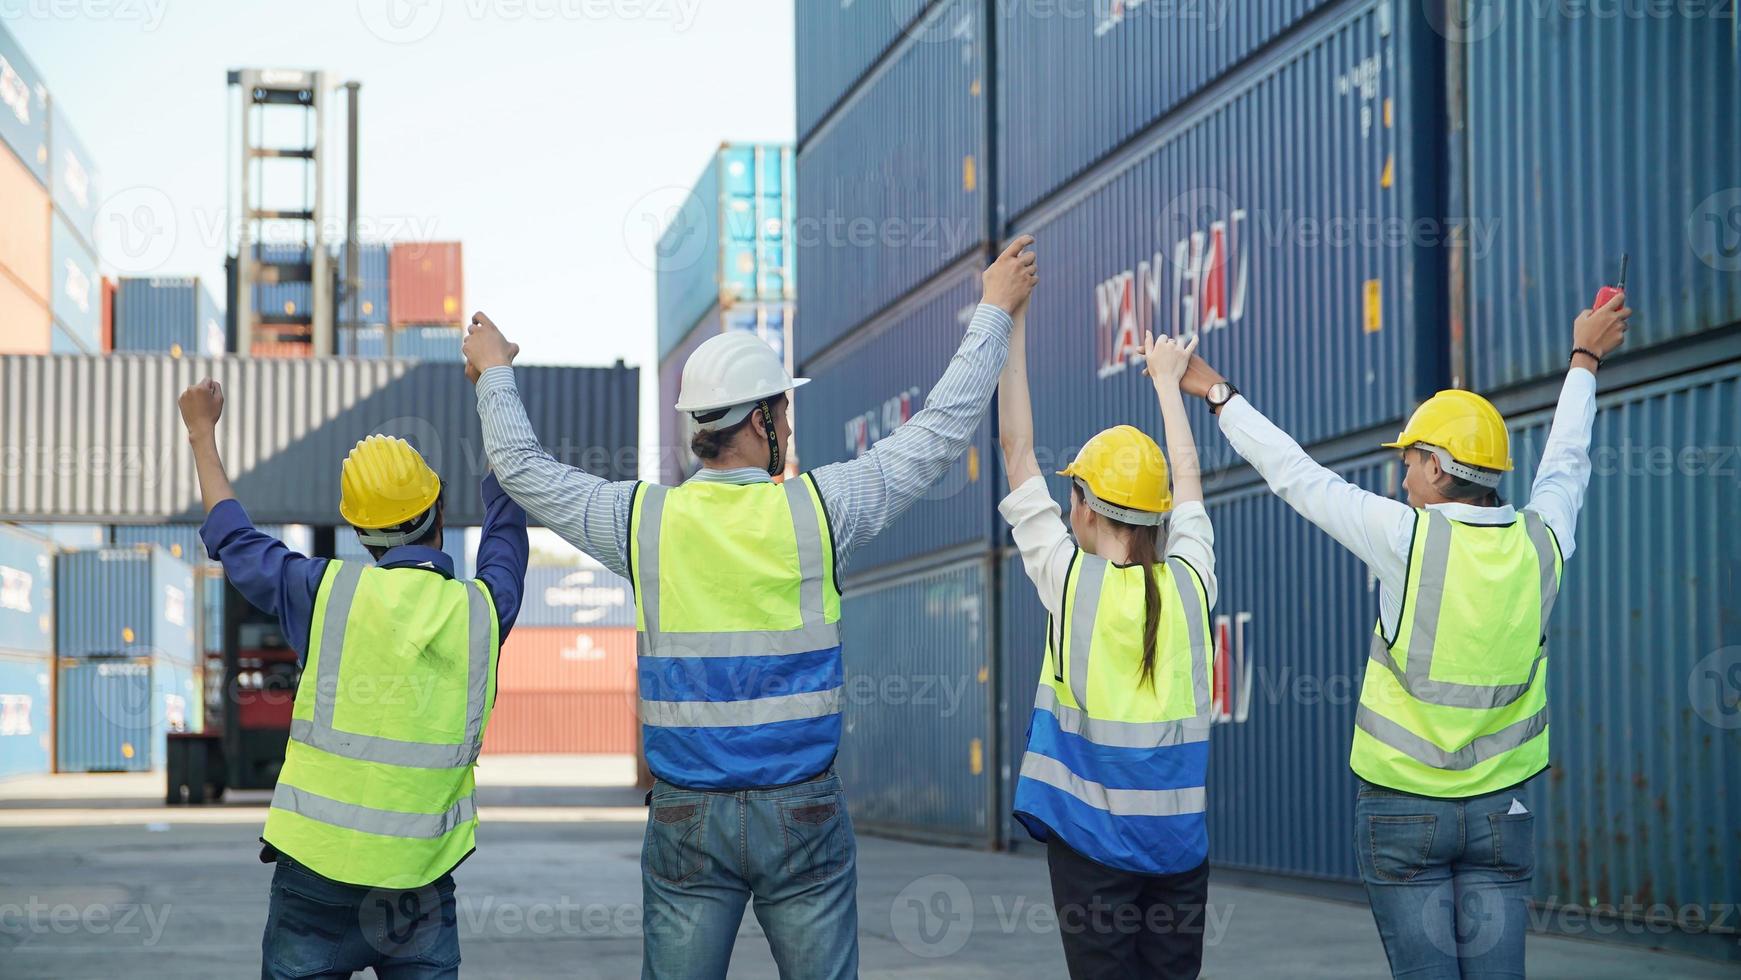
top-left (465, 237), bottom-right (1038, 980)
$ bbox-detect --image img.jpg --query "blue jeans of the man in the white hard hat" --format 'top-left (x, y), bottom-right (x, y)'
top-left (641, 771), bottom-right (858, 980)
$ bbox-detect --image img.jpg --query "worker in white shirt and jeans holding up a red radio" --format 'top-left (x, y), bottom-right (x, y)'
top-left (1184, 292), bottom-right (1631, 980)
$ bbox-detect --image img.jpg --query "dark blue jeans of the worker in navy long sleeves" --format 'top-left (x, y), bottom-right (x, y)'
top-left (259, 855), bottom-right (460, 980)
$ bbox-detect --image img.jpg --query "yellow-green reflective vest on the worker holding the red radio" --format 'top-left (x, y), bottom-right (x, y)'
top-left (1349, 510), bottom-right (1560, 799)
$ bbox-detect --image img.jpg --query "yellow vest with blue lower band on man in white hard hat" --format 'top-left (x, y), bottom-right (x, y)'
top-left (629, 475), bottom-right (843, 790)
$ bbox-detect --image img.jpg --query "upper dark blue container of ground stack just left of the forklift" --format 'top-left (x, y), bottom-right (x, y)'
top-left (56, 547), bottom-right (198, 661)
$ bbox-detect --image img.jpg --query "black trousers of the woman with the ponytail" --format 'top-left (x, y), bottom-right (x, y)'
top-left (1046, 837), bottom-right (1208, 980)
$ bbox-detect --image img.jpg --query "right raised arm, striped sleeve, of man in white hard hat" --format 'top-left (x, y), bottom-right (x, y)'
top-left (811, 235), bottom-right (1039, 560)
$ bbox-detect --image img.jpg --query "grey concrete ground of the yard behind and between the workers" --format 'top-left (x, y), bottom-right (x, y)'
top-left (0, 757), bottom-right (1734, 980)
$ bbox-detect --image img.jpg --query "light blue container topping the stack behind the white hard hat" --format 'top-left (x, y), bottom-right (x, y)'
top-left (656, 143), bottom-right (794, 357)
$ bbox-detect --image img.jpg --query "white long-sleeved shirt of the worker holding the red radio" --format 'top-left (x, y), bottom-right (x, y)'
top-left (1219, 367), bottom-right (1596, 635)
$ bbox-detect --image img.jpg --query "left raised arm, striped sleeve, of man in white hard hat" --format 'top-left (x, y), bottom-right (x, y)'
top-left (463, 313), bottom-right (635, 578)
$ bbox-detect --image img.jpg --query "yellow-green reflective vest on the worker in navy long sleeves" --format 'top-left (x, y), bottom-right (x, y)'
top-left (261, 560), bottom-right (501, 889)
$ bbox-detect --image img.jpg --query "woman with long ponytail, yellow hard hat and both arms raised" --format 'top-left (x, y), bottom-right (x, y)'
top-left (998, 310), bottom-right (1215, 980)
